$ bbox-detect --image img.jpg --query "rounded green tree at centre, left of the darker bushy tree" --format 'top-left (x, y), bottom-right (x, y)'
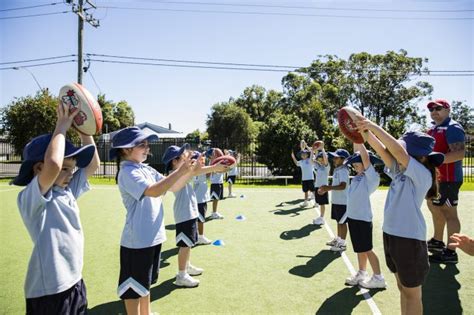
top-left (206, 103), bottom-right (257, 151)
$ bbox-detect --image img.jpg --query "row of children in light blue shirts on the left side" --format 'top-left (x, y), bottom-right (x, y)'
top-left (12, 103), bottom-right (241, 315)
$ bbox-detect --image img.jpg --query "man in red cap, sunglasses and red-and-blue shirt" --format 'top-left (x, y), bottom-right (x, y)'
top-left (427, 99), bottom-right (465, 264)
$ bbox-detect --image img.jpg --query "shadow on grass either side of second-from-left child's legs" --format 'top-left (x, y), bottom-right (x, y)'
top-left (87, 278), bottom-right (180, 315)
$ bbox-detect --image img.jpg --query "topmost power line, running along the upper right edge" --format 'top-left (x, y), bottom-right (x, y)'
top-left (131, 0), bottom-right (474, 13)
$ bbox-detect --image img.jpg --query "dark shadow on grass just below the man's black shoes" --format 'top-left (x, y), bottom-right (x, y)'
top-left (422, 263), bottom-right (462, 315)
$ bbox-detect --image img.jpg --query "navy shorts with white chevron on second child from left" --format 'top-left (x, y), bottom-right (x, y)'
top-left (117, 244), bottom-right (161, 300)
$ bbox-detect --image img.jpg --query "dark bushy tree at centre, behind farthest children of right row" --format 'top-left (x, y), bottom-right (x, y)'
top-left (257, 112), bottom-right (316, 176)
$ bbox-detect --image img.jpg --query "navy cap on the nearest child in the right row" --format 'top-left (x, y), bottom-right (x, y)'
top-left (398, 131), bottom-right (444, 166)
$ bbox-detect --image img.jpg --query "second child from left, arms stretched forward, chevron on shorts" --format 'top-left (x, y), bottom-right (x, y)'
top-left (109, 127), bottom-right (194, 314)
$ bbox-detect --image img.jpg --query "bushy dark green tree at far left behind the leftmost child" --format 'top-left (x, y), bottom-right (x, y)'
top-left (0, 90), bottom-right (79, 154)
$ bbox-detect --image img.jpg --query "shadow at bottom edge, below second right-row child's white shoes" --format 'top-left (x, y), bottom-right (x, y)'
top-left (316, 287), bottom-right (383, 315)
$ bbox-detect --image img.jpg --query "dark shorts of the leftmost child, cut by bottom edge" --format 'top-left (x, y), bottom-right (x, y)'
top-left (26, 279), bottom-right (87, 315)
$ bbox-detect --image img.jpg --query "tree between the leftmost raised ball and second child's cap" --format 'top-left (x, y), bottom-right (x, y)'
top-left (97, 94), bottom-right (135, 133)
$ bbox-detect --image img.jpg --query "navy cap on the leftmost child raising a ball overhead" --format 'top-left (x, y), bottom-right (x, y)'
top-left (11, 134), bottom-right (95, 186)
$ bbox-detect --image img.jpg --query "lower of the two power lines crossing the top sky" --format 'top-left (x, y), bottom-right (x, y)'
top-left (97, 6), bottom-right (474, 21)
